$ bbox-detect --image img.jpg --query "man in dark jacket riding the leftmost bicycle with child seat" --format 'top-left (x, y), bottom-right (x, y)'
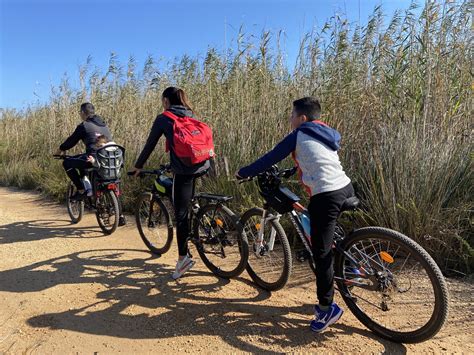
top-left (56, 102), bottom-right (126, 225)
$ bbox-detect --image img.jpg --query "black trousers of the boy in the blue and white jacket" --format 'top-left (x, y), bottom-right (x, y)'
top-left (308, 183), bottom-right (354, 306)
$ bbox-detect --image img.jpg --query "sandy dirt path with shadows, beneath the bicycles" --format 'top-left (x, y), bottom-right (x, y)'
top-left (0, 188), bottom-right (474, 354)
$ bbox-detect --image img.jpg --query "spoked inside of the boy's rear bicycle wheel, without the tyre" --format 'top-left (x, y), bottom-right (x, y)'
top-left (336, 232), bottom-right (447, 340)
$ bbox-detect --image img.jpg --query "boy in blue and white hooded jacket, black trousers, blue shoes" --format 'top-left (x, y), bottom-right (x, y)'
top-left (236, 97), bottom-right (354, 332)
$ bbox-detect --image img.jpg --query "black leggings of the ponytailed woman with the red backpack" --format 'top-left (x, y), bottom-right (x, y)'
top-left (173, 174), bottom-right (196, 256)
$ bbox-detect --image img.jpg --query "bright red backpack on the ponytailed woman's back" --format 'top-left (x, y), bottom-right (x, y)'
top-left (163, 111), bottom-right (215, 166)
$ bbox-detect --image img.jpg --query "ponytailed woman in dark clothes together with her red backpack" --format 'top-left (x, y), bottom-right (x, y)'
top-left (134, 87), bottom-right (214, 279)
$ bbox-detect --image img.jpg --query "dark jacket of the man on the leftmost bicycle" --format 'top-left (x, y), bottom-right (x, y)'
top-left (59, 116), bottom-right (112, 154)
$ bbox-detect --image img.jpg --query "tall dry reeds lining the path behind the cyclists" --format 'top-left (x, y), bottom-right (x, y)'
top-left (0, 1), bottom-right (474, 272)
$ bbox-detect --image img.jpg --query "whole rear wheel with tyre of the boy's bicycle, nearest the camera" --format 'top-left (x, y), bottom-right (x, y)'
top-left (335, 227), bottom-right (448, 343)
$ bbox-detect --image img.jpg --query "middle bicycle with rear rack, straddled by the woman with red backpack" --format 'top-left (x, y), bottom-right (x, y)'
top-left (128, 165), bottom-right (248, 279)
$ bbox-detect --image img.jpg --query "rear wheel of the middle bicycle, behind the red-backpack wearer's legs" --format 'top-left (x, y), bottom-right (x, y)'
top-left (194, 204), bottom-right (248, 279)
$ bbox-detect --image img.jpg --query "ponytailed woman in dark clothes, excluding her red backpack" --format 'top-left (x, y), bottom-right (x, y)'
top-left (134, 87), bottom-right (210, 279)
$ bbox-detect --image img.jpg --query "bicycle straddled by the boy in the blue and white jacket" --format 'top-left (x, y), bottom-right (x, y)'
top-left (241, 166), bottom-right (448, 343)
